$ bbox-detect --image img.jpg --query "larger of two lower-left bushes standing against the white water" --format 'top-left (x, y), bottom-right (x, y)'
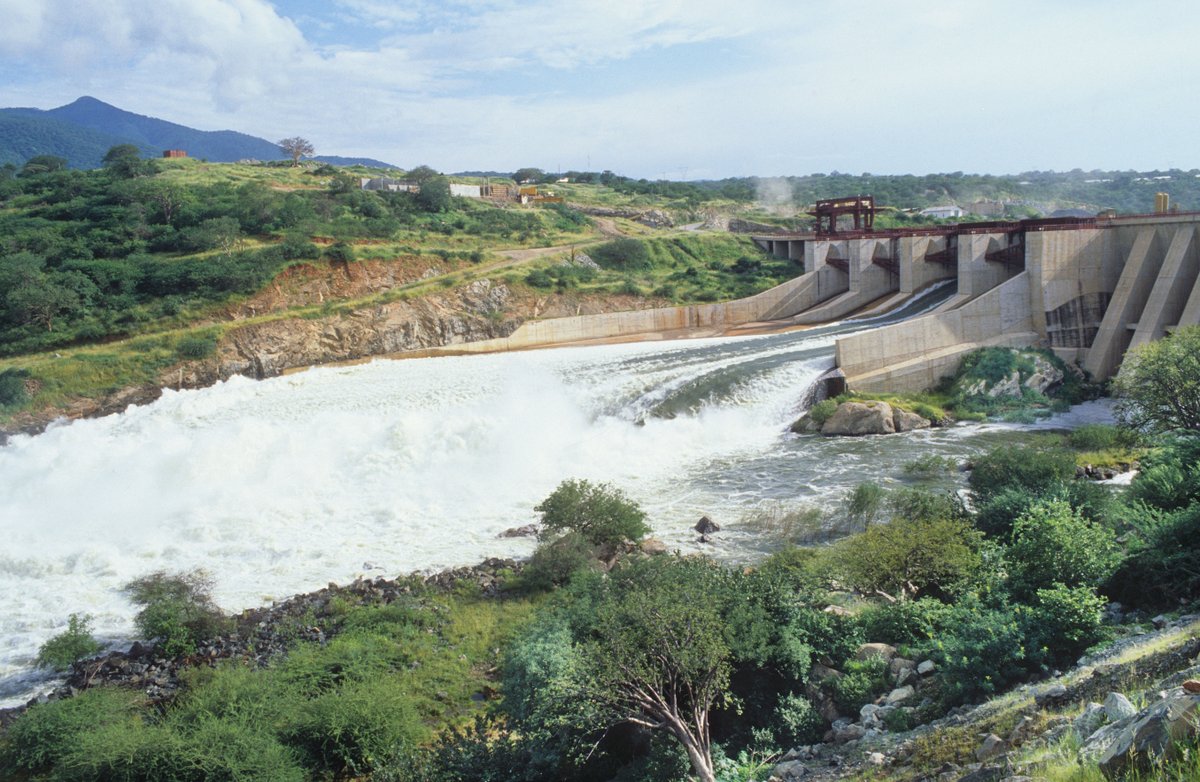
top-left (125, 571), bottom-right (228, 656)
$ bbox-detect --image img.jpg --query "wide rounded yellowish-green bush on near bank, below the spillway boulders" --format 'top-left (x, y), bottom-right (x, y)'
top-left (829, 518), bottom-right (980, 596)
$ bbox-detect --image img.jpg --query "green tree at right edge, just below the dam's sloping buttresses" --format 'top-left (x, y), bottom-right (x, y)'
top-left (1112, 326), bottom-right (1200, 432)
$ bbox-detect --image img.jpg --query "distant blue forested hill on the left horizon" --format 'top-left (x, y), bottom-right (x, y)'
top-left (0, 96), bottom-right (391, 168)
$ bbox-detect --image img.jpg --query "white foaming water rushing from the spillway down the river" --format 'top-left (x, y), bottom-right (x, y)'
top-left (0, 283), bottom-right (1012, 703)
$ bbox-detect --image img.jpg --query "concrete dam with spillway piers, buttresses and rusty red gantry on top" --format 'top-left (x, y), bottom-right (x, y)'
top-left (755, 197), bottom-right (1200, 391)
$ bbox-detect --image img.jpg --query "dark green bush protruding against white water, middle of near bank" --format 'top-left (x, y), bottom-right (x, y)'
top-left (534, 479), bottom-right (650, 546)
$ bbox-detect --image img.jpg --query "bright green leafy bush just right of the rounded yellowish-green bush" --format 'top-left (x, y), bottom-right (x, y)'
top-left (1006, 499), bottom-right (1120, 600)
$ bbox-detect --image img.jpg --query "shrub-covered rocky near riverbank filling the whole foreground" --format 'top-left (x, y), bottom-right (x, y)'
top-left (0, 329), bottom-right (1200, 781)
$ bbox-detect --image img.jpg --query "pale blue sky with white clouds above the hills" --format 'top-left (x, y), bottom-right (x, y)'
top-left (0, 0), bottom-right (1200, 179)
